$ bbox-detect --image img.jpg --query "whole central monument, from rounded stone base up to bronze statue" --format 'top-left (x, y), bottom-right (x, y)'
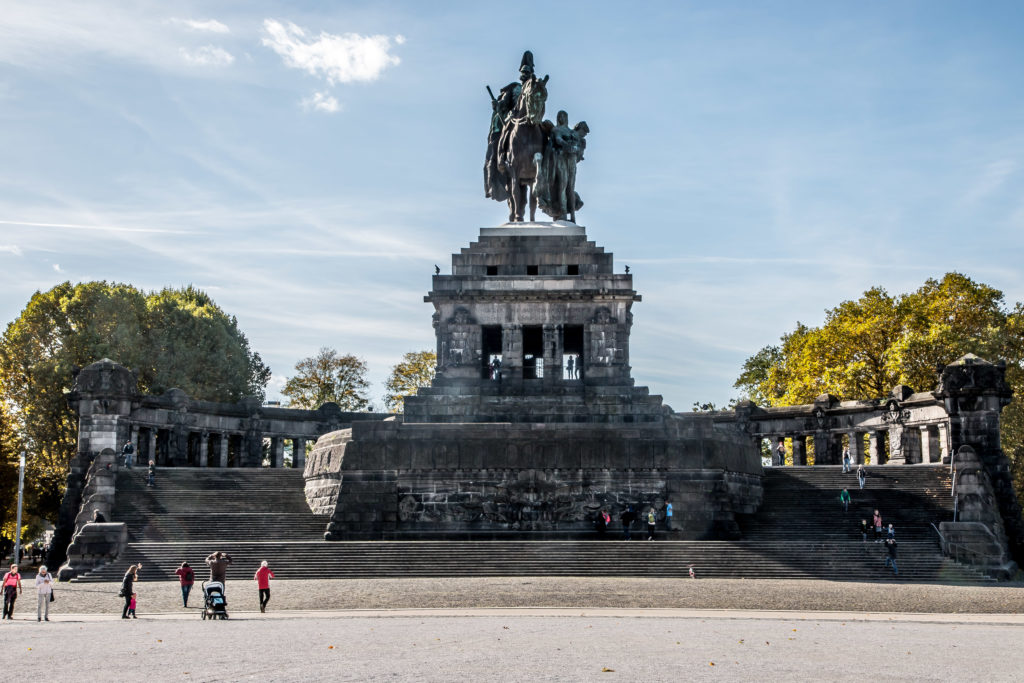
top-left (305, 52), bottom-right (762, 540)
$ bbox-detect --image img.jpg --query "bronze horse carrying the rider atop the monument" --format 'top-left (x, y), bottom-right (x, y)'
top-left (498, 76), bottom-right (548, 222)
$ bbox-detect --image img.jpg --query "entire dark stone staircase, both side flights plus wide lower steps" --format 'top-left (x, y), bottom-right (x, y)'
top-left (76, 466), bottom-right (988, 583)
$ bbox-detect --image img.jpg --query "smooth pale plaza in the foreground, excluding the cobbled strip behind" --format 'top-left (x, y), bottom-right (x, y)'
top-left (0, 610), bottom-right (1024, 682)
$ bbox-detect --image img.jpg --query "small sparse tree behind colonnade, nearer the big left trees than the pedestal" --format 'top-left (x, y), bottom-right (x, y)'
top-left (282, 346), bottom-right (370, 411)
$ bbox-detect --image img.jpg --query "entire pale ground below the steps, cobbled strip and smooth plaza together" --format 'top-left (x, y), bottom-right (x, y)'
top-left (0, 579), bottom-right (1024, 681)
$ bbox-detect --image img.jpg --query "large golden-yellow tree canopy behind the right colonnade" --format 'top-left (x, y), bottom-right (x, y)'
top-left (734, 272), bottom-right (1024, 492)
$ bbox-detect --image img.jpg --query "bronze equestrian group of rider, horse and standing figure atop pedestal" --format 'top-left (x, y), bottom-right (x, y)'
top-left (483, 51), bottom-right (590, 222)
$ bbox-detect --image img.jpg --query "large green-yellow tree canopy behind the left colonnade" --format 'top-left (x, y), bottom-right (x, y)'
top-left (0, 282), bottom-right (270, 532)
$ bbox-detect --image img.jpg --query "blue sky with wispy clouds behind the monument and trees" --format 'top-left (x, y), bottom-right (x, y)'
top-left (0, 0), bottom-right (1024, 410)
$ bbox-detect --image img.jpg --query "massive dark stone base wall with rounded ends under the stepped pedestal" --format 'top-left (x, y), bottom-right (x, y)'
top-left (305, 416), bottom-right (761, 540)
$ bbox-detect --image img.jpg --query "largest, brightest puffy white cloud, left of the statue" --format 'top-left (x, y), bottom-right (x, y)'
top-left (263, 19), bottom-right (404, 85)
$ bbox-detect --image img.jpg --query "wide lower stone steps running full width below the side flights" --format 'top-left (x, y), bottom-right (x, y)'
top-left (68, 541), bottom-right (985, 583)
